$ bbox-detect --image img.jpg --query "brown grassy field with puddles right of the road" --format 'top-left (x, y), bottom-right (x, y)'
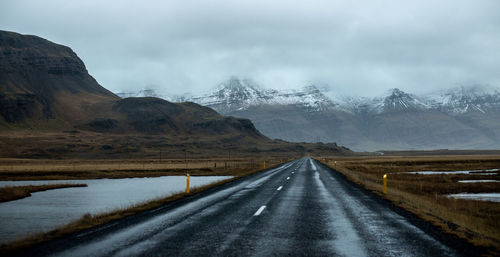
top-left (317, 156), bottom-right (500, 253)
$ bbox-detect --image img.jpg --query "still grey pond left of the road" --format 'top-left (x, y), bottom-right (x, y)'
top-left (0, 176), bottom-right (231, 244)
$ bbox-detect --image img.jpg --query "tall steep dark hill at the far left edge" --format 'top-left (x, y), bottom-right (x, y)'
top-left (0, 31), bottom-right (119, 128)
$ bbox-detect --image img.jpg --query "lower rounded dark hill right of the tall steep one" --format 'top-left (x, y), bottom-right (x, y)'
top-left (76, 97), bottom-right (267, 139)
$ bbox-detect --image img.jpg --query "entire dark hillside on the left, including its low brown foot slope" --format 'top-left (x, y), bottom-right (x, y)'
top-left (0, 31), bottom-right (347, 158)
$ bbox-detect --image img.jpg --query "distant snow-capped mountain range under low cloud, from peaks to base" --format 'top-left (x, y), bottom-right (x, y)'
top-left (179, 78), bottom-right (500, 151)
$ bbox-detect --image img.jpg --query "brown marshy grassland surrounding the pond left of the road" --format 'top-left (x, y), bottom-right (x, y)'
top-left (0, 158), bottom-right (288, 252)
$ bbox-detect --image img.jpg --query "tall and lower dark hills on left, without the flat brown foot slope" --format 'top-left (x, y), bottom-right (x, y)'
top-left (0, 31), bottom-right (263, 137)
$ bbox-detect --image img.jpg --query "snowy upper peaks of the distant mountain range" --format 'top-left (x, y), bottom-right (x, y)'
top-left (114, 77), bottom-right (500, 114)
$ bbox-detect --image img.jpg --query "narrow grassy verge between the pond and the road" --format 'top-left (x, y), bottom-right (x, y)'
top-left (0, 162), bottom-right (281, 256)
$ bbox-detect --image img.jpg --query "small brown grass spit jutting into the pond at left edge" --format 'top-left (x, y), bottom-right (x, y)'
top-left (0, 184), bottom-right (87, 202)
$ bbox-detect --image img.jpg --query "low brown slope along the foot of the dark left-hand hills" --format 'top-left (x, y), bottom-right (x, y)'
top-left (0, 129), bottom-right (346, 160)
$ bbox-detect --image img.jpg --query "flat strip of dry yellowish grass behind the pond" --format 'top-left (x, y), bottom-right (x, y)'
top-left (0, 157), bottom-right (289, 180)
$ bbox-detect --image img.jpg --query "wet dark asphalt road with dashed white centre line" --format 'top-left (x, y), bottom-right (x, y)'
top-left (29, 158), bottom-right (472, 257)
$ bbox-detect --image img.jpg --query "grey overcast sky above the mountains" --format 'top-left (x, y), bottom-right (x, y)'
top-left (0, 0), bottom-right (500, 96)
